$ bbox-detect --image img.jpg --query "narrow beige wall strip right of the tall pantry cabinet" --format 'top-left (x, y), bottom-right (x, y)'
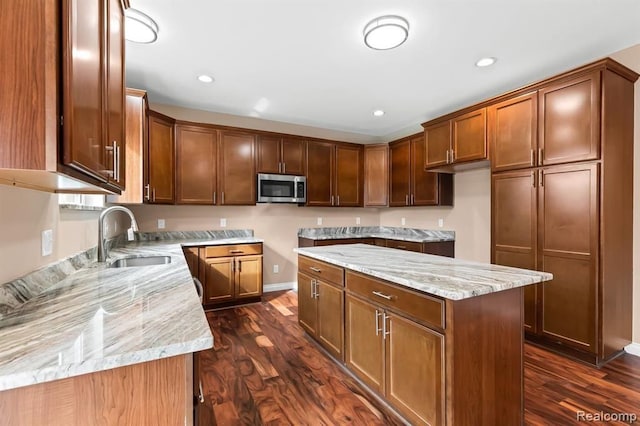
top-left (611, 44), bottom-right (640, 344)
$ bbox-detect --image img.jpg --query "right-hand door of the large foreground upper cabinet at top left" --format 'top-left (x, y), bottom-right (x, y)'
top-left (105, 0), bottom-right (127, 189)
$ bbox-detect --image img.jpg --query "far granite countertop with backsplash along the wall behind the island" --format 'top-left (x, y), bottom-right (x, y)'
top-left (298, 226), bottom-right (455, 243)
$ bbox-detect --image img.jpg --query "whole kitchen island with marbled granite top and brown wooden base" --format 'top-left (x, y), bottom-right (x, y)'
top-left (297, 244), bottom-right (553, 425)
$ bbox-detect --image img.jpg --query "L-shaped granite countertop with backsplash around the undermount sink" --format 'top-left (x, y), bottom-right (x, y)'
top-left (0, 231), bottom-right (262, 390)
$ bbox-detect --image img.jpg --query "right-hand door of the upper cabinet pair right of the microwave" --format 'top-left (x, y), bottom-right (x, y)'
top-left (334, 145), bottom-right (363, 207)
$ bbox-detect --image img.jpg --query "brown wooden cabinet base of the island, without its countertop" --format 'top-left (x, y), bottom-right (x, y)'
top-left (298, 256), bottom-right (524, 426)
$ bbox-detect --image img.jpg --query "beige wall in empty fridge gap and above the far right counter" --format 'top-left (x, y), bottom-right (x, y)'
top-left (380, 168), bottom-right (491, 262)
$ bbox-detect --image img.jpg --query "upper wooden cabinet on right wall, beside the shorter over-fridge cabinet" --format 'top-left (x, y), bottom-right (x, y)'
top-left (389, 134), bottom-right (453, 207)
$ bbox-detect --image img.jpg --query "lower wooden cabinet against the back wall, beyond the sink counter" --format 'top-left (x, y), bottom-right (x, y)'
top-left (190, 243), bottom-right (262, 307)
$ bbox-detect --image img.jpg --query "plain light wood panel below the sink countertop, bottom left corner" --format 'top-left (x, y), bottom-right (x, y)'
top-left (0, 354), bottom-right (194, 426)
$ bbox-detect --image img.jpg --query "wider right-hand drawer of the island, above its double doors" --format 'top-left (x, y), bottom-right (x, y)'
top-left (346, 271), bottom-right (445, 329)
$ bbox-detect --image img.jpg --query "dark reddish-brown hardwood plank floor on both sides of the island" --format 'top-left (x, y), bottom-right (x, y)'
top-left (200, 292), bottom-right (640, 426)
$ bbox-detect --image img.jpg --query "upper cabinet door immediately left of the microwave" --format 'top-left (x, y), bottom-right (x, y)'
top-left (218, 130), bottom-right (256, 205)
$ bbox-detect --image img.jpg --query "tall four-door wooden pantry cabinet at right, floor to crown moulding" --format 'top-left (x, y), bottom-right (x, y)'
top-left (488, 59), bottom-right (638, 365)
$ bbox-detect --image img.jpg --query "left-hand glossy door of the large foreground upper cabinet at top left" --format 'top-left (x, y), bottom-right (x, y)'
top-left (61, 0), bottom-right (106, 181)
